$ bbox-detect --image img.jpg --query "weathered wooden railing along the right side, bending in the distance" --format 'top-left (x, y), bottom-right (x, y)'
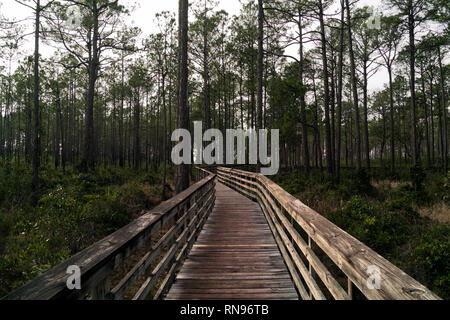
top-left (217, 167), bottom-right (440, 300)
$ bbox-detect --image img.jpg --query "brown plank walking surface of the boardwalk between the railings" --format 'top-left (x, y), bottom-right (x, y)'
top-left (166, 183), bottom-right (298, 300)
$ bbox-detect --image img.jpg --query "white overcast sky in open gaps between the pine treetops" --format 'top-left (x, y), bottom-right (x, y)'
top-left (0, 0), bottom-right (387, 91)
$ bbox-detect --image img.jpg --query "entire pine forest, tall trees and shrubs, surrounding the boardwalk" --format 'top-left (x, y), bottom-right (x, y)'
top-left (0, 0), bottom-right (450, 299)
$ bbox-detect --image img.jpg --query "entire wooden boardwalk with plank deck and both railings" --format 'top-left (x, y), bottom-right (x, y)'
top-left (4, 167), bottom-right (440, 300)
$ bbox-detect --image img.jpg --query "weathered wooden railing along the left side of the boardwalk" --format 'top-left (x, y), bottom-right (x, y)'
top-left (4, 170), bottom-right (216, 300)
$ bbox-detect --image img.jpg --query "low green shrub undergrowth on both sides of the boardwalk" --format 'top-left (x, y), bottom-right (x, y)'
top-left (0, 161), bottom-right (450, 299)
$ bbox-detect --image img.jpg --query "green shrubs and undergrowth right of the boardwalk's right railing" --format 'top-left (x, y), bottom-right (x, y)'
top-left (274, 168), bottom-right (450, 299)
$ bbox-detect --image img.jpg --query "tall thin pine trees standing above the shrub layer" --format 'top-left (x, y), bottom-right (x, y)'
top-left (0, 0), bottom-right (449, 191)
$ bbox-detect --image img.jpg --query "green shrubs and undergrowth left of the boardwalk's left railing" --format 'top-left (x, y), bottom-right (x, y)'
top-left (0, 167), bottom-right (165, 296)
